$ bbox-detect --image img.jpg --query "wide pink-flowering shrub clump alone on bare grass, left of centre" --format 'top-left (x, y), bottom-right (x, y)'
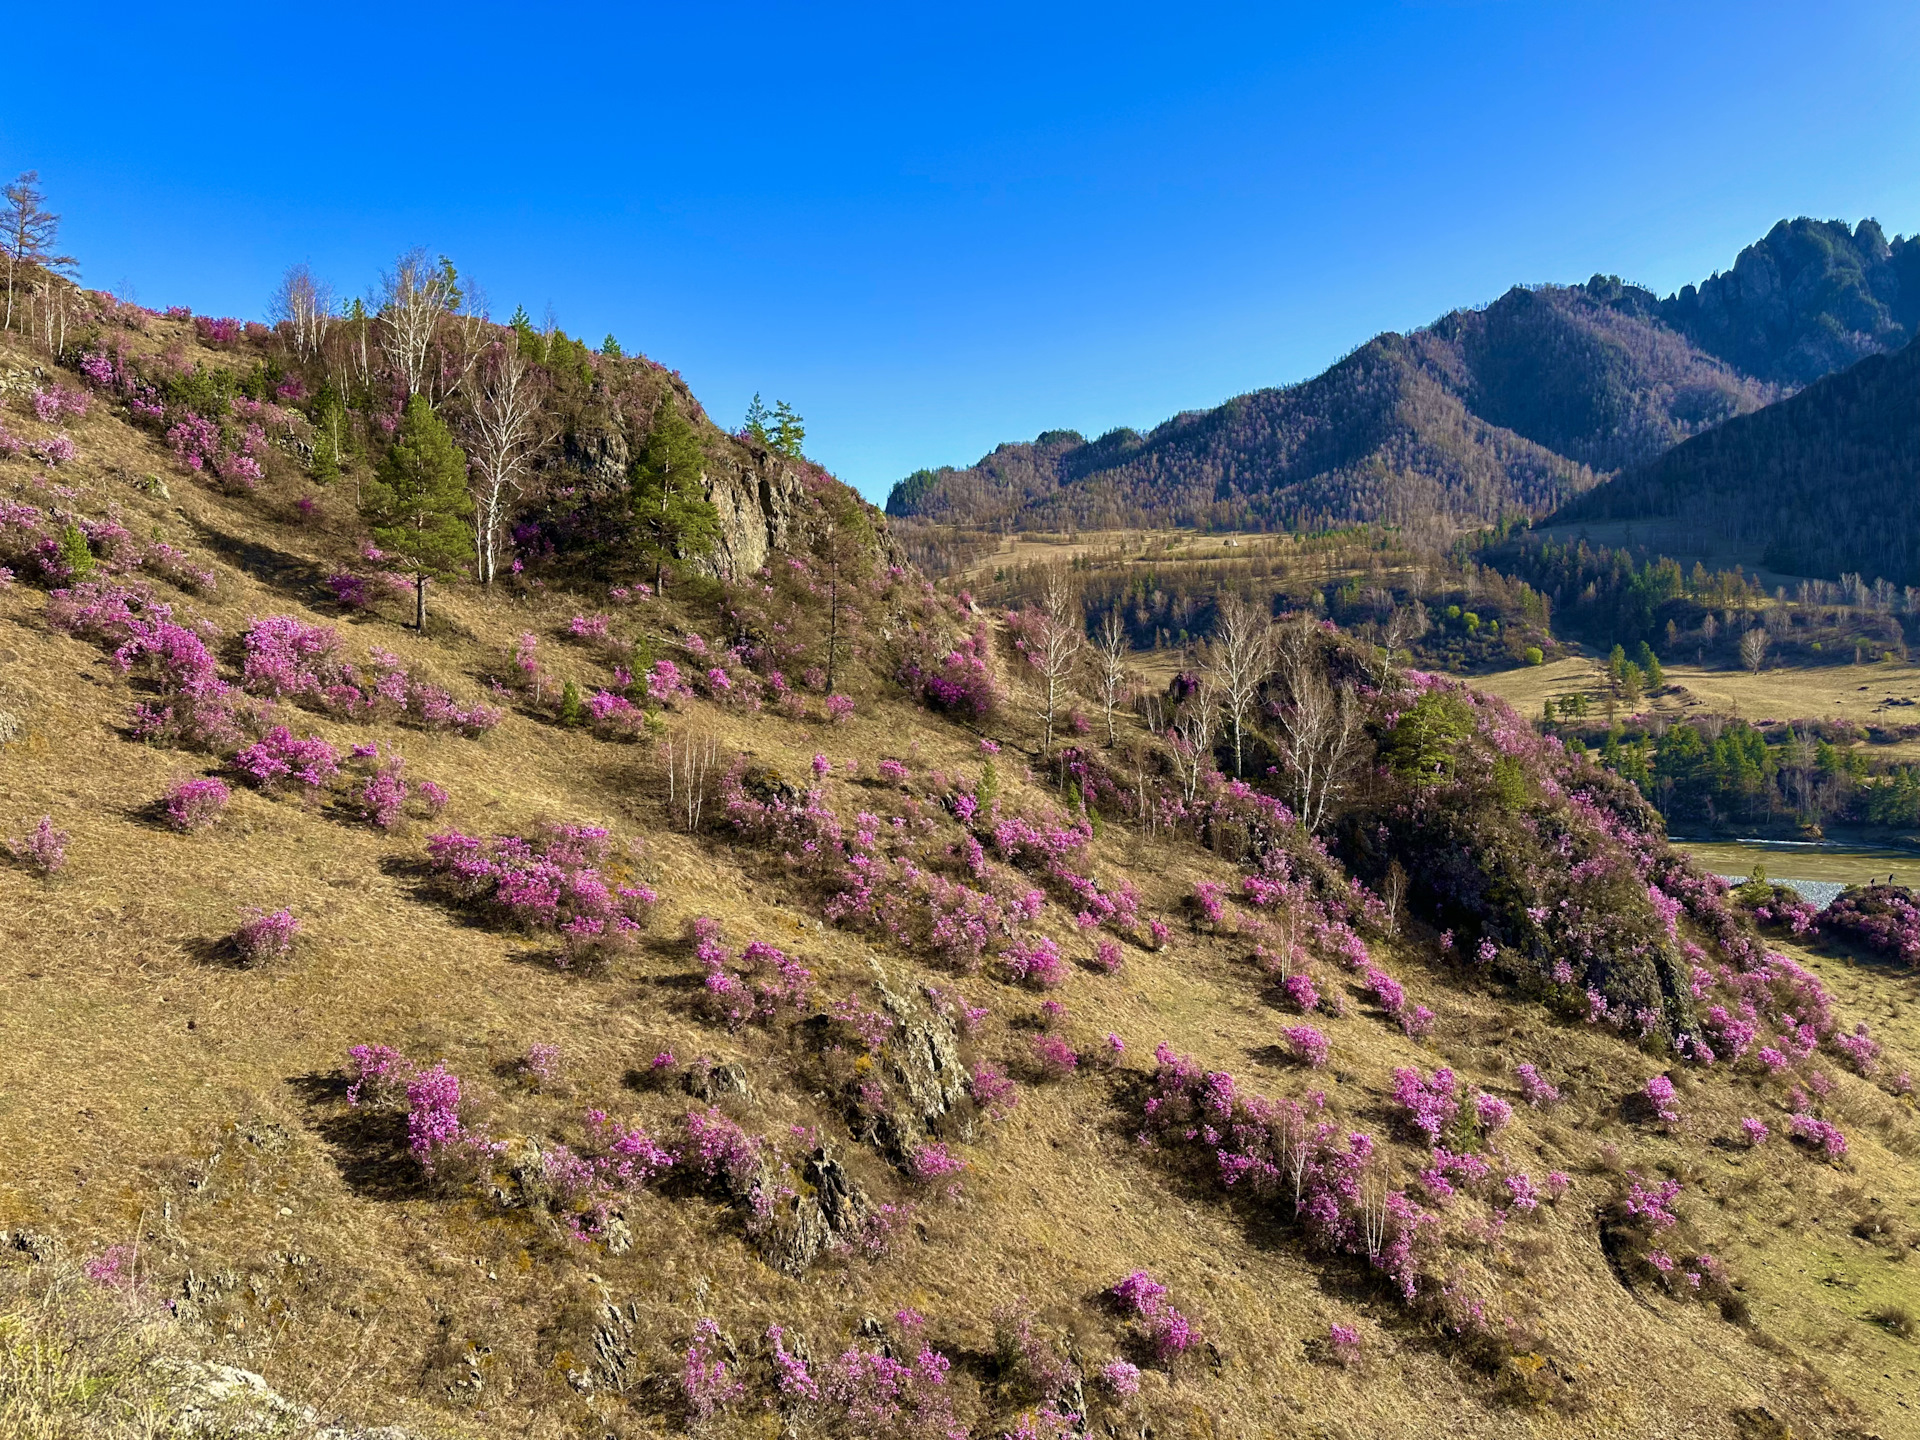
top-left (426, 824), bottom-right (659, 970)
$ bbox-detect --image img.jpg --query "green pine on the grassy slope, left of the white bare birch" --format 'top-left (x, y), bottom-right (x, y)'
top-left (361, 396), bottom-right (474, 630)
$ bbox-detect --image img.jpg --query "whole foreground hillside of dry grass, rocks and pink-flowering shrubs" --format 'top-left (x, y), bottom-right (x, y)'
top-left (0, 284), bottom-right (1920, 1440)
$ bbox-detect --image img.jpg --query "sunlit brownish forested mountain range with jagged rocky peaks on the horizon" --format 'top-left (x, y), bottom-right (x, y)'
top-left (887, 221), bottom-right (1920, 530)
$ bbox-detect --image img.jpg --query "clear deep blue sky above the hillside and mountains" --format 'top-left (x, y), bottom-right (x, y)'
top-left (0, 0), bottom-right (1920, 499)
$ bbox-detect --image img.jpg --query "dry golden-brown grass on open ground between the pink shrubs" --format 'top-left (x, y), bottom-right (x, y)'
top-left (0, 341), bottom-right (1920, 1436)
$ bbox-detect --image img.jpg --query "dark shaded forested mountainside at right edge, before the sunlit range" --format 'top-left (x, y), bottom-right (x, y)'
top-left (1551, 332), bottom-right (1920, 586)
